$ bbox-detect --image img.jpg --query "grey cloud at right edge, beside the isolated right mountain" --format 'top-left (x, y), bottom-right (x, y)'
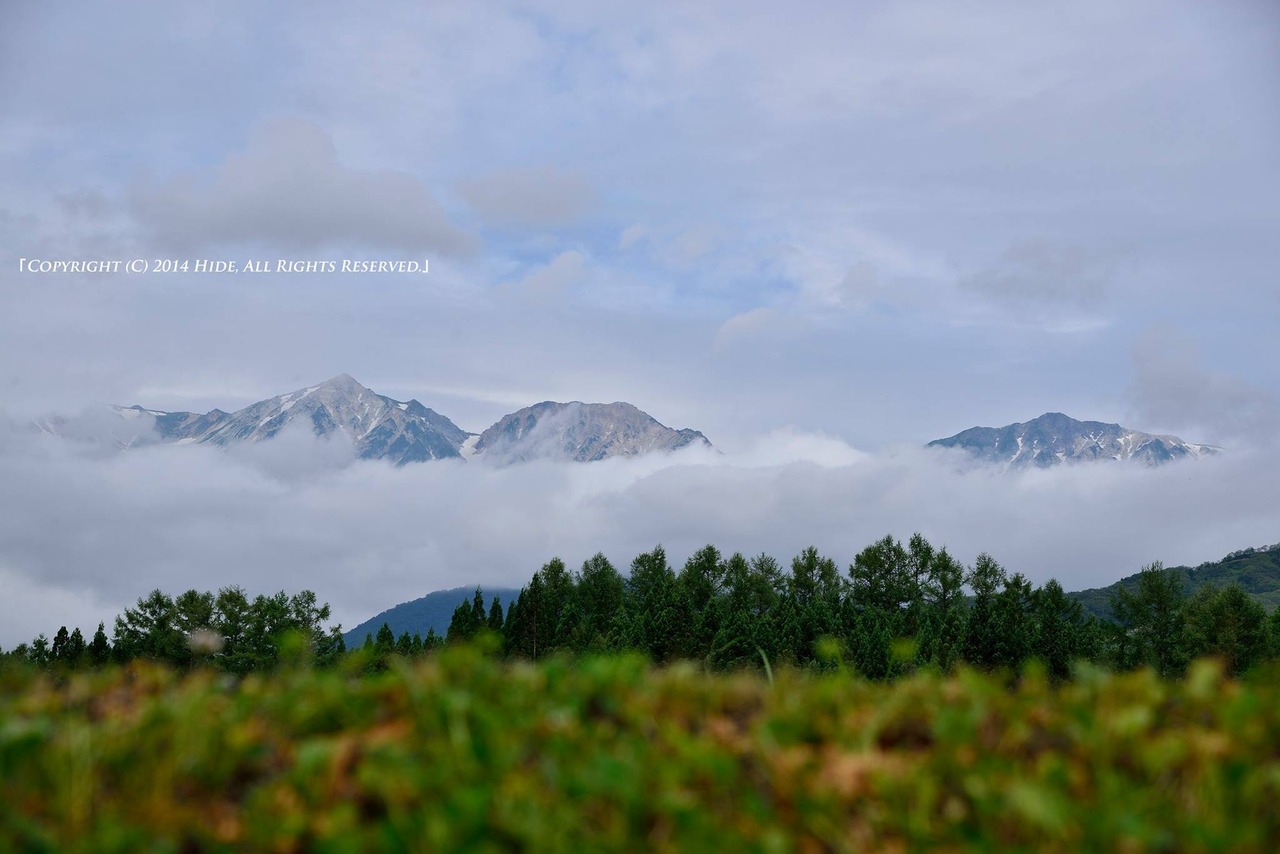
top-left (1125, 328), bottom-right (1280, 446)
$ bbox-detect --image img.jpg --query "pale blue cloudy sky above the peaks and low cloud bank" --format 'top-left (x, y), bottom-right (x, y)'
top-left (0, 0), bottom-right (1280, 640)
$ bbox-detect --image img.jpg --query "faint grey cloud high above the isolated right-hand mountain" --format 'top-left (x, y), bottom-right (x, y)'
top-left (960, 238), bottom-right (1115, 311)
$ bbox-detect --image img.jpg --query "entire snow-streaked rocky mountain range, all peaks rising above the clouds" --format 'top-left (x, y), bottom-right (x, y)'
top-left (36, 374), bottom-right (1221, 470)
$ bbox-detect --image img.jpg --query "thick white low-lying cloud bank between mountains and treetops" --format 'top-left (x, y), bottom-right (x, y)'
top-left (0, 430), bottom-right (1280, 648)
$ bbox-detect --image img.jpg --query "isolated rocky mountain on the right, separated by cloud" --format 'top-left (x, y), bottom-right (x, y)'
top-left (929, 412), bottom-right (1221, 469)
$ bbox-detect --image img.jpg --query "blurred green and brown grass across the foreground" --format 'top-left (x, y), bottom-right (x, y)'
top-left (0, 648), bottom-right (1280, 851)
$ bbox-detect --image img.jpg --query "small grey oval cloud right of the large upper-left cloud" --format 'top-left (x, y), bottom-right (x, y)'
top-left (458, 166), bottom-right (594, 228)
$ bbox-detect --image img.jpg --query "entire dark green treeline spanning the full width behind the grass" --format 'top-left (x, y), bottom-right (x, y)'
top-left (8, 534), bottom-right (1280, 680)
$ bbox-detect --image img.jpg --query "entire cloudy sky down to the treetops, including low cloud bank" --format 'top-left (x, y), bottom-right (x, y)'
top-left (0, 0), bottom-right (1280, 647)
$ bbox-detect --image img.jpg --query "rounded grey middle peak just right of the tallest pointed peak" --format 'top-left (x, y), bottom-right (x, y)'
top-left (474, 401), bottom-right (712, 463)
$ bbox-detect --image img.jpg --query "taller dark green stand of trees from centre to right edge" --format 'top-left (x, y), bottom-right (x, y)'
top-left (442, 534), bottom-right (1280, 680)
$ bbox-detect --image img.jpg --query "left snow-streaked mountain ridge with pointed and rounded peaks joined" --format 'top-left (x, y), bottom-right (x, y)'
top-left (36, 374), bottom-right (712, 466)
